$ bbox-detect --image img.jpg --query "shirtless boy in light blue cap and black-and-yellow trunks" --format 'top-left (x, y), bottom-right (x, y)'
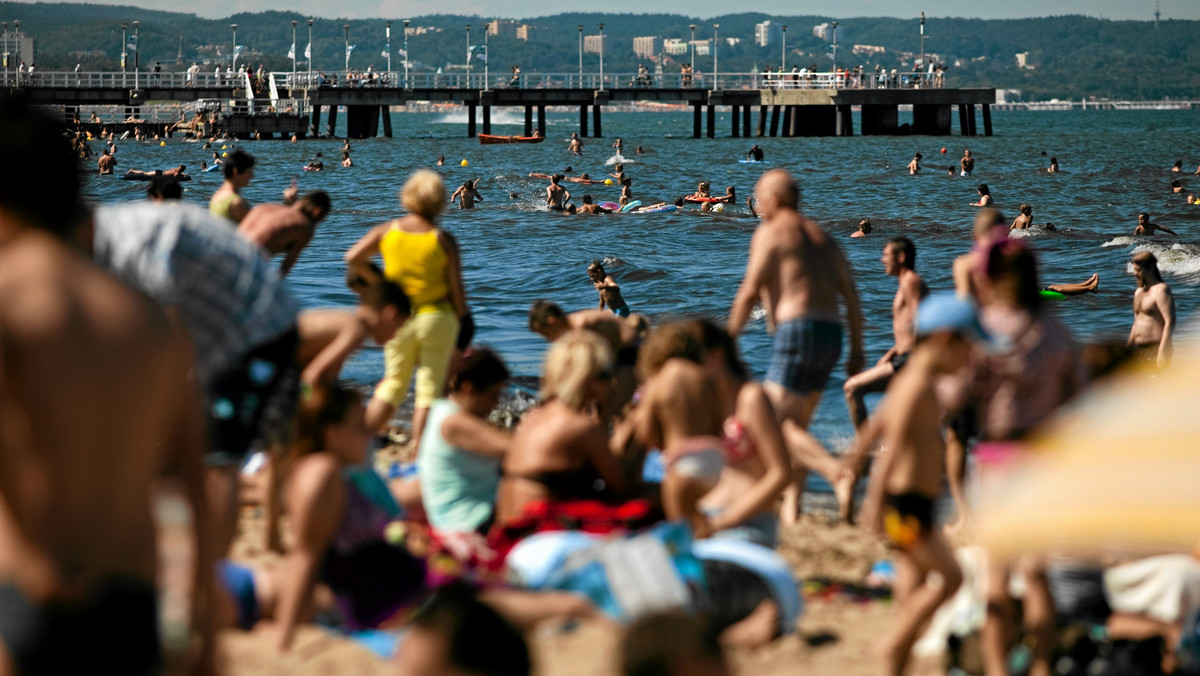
top-left (851, 293), bottom-right (969, 675)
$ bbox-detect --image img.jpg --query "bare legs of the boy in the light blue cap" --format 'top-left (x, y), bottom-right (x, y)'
top-left (881, 533), bottom-right (962, 675)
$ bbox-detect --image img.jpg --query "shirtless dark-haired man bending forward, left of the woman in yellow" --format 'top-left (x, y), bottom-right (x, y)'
top-left (238, 190), bottom-right (331, 276)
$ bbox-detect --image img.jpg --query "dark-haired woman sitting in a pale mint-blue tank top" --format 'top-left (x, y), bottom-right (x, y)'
top-left (416, 348), bottom-right (510, 533)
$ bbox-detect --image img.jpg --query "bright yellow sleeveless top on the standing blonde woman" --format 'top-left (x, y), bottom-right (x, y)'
top-left (379, 223), bottom-right (450, 312)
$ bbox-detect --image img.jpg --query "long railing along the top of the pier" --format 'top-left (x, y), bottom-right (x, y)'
top-left (6, 71), bottom-right (943, 91)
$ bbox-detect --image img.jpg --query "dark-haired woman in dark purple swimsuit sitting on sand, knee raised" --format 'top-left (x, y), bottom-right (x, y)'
top-left (221, 388), bottom-right (599, 651)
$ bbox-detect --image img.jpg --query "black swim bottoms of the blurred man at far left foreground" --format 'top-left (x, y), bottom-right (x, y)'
top-left (0, 576), bottom-right (162, 676)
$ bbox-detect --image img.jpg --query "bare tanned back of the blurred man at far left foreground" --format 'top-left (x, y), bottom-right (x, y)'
top-left (0, 233), bottom-right (192, 588)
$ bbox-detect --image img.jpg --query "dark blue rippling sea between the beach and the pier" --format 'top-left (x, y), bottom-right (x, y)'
top-left (79, 109), bottom-right (1200, 461)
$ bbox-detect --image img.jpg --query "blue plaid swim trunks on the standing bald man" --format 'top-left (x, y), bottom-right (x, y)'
top-left (767, 318), bottom-right (842, 395)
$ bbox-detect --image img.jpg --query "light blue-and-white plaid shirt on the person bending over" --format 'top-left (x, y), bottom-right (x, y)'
top-left (95, 202), bottom-right (299, 385)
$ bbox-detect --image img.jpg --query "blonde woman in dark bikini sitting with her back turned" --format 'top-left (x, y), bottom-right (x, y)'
top-left (496, 331), bottom-right (629, 525)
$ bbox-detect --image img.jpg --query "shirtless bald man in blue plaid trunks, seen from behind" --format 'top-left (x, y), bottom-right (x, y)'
top-left (728, 169), bottom-right (863, 524)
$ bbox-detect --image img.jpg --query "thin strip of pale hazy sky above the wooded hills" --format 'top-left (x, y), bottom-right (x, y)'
top-left (28, 0), bottom-right (1200, 20)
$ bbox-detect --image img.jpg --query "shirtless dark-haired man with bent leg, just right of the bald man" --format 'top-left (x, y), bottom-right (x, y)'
top-left (842, 237), bottom-right (929, 429)
